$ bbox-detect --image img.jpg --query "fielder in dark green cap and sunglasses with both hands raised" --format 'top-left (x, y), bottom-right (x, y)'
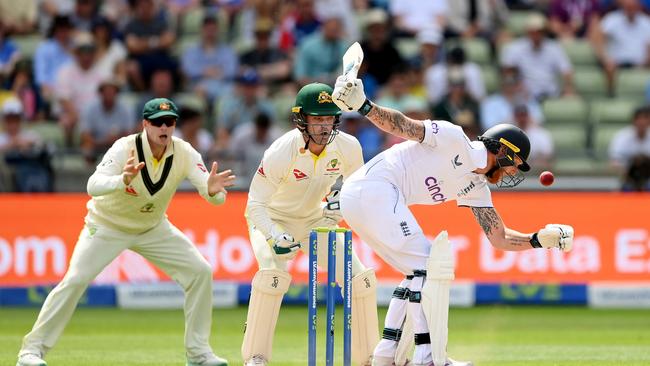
top-left (17, 98), bottom-right (235, 366)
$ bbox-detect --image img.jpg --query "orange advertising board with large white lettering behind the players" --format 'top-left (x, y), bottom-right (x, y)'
top-left (0, 192), bottom-right (650, 286)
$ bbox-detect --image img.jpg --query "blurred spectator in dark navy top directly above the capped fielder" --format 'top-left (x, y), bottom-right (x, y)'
top-left (124, 0), bottom-right (177, 90)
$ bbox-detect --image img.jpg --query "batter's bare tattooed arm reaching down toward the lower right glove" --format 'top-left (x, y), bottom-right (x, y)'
top-left (472, 207), bottom-right (533, 251)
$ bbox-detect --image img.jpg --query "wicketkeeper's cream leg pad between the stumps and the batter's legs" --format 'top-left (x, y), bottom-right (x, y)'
top-left (352, 269), bottom-right (379, 365)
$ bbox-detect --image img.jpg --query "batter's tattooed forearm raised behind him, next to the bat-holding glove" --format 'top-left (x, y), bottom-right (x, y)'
top-left (367, 104), bottom-right (424, 142)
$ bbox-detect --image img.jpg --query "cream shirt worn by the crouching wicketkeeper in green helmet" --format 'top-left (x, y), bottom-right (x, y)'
top-left (246, 129), bottom-right (363, 237)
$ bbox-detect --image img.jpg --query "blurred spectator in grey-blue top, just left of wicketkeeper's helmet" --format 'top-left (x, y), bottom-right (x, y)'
top-left (215, 69), bottom-right (275, 150)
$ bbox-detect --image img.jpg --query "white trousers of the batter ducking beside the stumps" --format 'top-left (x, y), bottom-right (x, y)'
top-left (340, 177), bottom-right (431, 275)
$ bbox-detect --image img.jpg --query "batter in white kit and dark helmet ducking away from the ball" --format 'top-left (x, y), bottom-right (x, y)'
top-left (332, 76), bottom-right (573, 366)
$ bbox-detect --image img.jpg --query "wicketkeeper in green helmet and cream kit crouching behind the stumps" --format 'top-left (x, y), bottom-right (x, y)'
top-left (241, 83), bottom-right (379, 365)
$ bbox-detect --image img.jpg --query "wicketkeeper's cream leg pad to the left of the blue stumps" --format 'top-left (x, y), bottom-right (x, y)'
top-left (241, 269), bottom-right (291, 361)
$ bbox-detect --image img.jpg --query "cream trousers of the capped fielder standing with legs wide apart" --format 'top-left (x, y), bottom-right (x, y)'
top-left (19, 219), bottom-right (212, 358)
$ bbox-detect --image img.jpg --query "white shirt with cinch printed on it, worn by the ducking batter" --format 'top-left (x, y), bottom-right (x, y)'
top-left (350, 120), bottom-right (493, 207)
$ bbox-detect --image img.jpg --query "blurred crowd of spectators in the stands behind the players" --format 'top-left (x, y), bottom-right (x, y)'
top-left (0, 0), bottom-right (650, 191)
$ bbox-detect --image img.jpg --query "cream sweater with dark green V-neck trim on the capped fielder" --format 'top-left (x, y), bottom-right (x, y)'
top-left (86, 132), bottom-right (225, 234)
